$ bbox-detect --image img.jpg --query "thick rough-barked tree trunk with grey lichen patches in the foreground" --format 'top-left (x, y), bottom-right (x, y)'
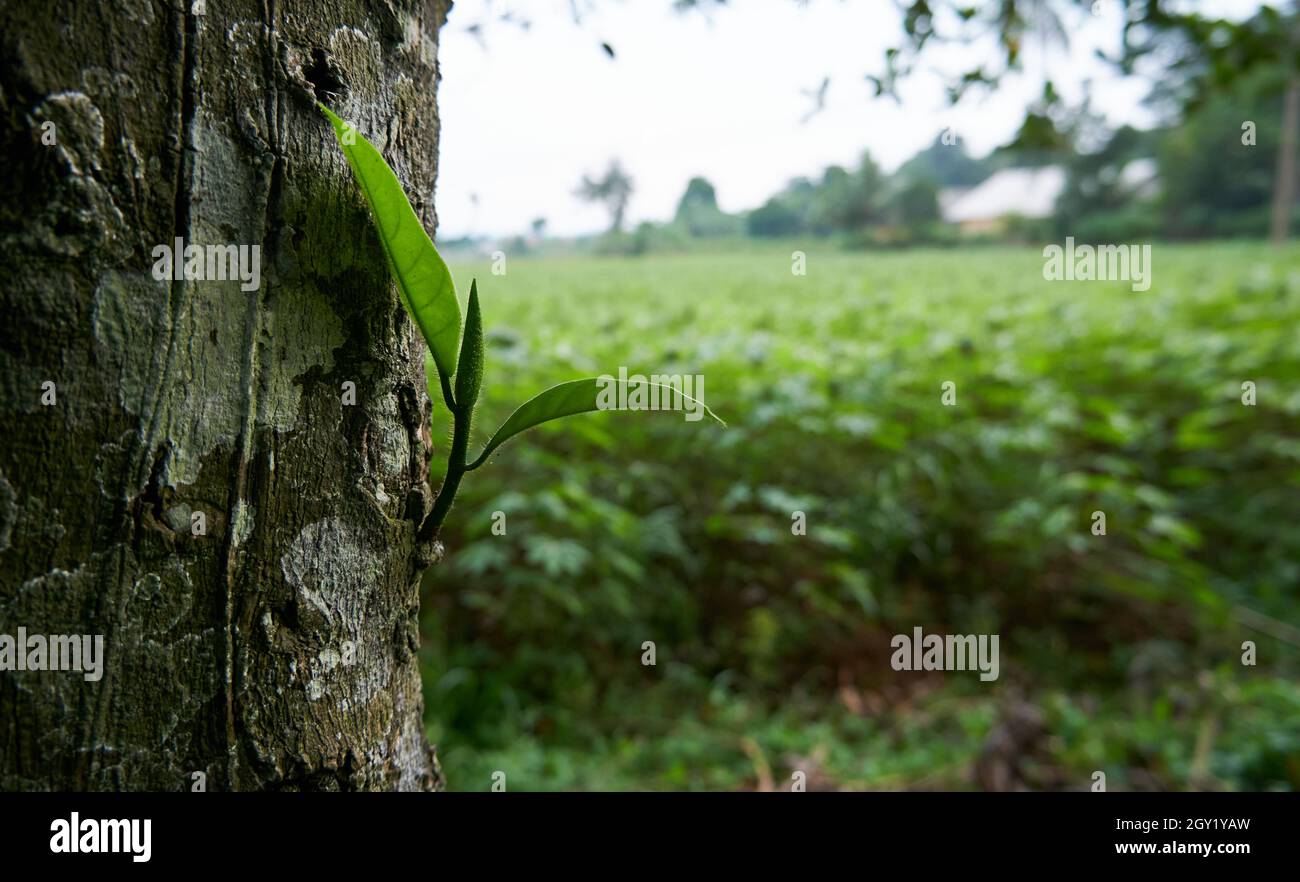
top-left (0, 0), bottom-right (450, 790)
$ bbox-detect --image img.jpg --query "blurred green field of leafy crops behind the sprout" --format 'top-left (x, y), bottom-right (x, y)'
top-left (423, 243), bottom-right (1300, 790)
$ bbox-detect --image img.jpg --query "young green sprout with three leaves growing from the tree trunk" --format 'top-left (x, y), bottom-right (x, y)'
top-left (317, 103), bottom-right (725, 542)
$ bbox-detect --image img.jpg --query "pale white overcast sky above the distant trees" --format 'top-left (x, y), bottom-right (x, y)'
top-left (437, 0), bottom-right (1257, 238)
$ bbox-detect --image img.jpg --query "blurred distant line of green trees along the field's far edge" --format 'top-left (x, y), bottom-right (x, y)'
top-left (446, 60), bottom-right (1294, 254)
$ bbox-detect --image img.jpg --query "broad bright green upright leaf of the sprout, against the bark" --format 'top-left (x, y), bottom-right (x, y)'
top-left (317, 101), bottom-right (460, 377)
